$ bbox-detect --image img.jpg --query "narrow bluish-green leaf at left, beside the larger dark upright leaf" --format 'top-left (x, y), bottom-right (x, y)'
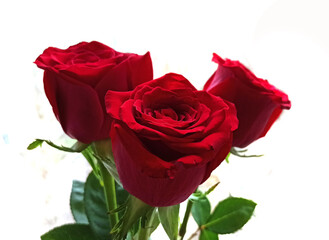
top-left (70, 180), bottom-right (88, 223)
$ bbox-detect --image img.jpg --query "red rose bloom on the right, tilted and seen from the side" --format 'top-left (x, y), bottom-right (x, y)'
top-left (204, 53), bottom-right (291, 148)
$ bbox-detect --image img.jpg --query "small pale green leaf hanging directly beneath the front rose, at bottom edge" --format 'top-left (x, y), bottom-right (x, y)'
top-left (158, 204), bottom-right (179, 240)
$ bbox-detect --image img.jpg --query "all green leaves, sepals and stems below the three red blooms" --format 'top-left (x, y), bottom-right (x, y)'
top-left (35, 139), bottom-right (256, 240)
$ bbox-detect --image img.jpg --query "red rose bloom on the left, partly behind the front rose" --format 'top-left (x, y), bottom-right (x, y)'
top-left (35, 42), bottom-right (153, 143)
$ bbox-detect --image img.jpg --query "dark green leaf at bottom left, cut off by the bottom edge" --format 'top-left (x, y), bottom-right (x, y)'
top-left (41, 223), bottom-right (95, 240)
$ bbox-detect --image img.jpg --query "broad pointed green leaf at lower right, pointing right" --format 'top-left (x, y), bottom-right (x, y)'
top-left (202, 197), bottom-right (256, 234)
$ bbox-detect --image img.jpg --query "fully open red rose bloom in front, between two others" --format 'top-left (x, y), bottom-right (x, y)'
top-left (105, 74), bottom-right (238, 206)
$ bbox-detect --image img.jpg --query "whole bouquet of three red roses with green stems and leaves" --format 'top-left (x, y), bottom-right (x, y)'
top-left (28, 42), bottom-right (290, 240)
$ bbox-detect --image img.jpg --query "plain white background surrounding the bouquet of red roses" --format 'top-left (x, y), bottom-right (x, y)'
top-left (0, 0), bottom-right (329, 240)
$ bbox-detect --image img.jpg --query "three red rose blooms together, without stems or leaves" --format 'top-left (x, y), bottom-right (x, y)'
top-left (35, 42), bottom-right (290, 206)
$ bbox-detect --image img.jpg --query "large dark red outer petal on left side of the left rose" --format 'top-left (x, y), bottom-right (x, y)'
top-left (44, 70), bottom-right (103, 143)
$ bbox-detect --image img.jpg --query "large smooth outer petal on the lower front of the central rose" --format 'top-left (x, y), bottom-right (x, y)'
top-left (111, 124), bottom-right (206, 207)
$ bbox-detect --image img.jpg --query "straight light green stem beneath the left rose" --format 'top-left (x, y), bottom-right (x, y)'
top-left (99, 161), bottom-right (119, 228)
